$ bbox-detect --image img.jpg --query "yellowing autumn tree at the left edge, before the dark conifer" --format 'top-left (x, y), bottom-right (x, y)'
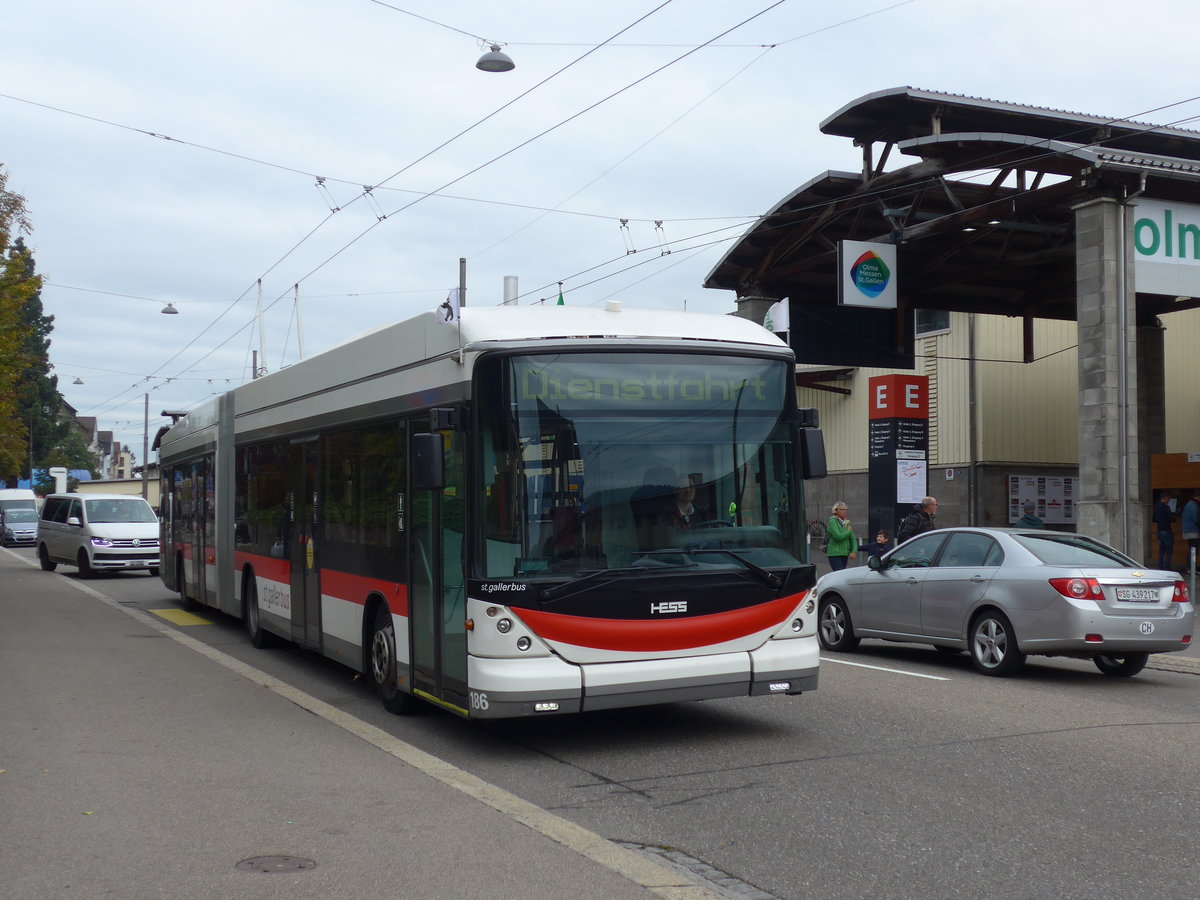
top-left (0, 167), bottom-right (42, 484)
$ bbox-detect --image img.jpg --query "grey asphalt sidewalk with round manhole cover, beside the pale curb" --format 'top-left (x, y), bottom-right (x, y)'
top-left (0, 551), bottom-right (719, 900)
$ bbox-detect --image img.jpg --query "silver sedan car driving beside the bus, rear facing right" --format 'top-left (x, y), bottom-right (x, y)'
top-left (815, 528), bottom-right (1195, 676)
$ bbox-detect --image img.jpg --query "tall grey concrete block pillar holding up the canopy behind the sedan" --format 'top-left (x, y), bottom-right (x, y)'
top-left (1075, 198), bottom-right (1148, 559)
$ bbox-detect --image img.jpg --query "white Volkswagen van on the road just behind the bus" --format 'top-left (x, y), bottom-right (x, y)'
top-left (37, 493), bottom-right (158, 577)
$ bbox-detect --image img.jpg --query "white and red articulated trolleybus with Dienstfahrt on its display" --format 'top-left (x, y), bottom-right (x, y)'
top-left (156, 305), bottom-right (824, 718)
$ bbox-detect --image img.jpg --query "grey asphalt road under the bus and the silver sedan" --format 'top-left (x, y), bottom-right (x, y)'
top-left (4, 551), bottom-right (1200, 900)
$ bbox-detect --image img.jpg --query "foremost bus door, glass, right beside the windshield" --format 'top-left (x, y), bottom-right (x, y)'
top-left (409, 431), bottom-right (468, 710)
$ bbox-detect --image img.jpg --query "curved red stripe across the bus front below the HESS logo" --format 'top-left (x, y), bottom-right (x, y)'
top-left (512, 592), bottom-right (806, 653)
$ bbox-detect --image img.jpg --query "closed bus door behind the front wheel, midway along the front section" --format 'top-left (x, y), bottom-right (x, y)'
top-left (288, 438), bottom-right (320, 648)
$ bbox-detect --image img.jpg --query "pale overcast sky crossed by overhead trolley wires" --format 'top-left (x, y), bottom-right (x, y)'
top-left (0, 0), bottom-right (1200, 458)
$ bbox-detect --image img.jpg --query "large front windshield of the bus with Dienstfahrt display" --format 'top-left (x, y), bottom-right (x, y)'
top-left (476, 353), bottom-right (804, 578)
